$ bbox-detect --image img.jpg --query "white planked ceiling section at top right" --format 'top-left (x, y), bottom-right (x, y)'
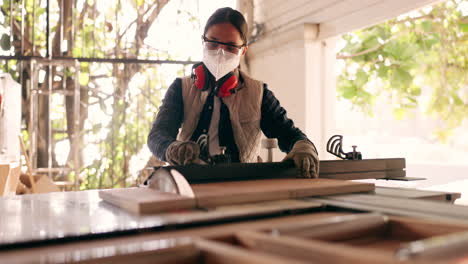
top-left (247, 0), bottom-right (441, 39)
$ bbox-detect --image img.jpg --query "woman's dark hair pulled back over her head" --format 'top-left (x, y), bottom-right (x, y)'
top-left (203, 7), bottom-right (247, 44)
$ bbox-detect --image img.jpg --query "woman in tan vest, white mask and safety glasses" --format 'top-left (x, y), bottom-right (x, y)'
top-left (148, 7), bottom-right (319, 178)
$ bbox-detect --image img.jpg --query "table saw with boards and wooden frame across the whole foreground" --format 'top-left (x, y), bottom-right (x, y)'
top-left (0, 159), bottom-right (468, 263)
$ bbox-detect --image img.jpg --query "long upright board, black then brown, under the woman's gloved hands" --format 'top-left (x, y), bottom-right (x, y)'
top-left (155, 158), bottom-right (406, 184)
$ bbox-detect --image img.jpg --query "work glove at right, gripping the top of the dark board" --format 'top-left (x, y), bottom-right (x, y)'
top-left (283, 140), bottom-right (319, 178)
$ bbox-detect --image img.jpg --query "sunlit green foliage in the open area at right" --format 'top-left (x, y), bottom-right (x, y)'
top-left (337, 0), bottom-right (468, 142)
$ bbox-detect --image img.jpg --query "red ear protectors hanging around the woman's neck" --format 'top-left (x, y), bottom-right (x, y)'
top-left (192, 62), bottom-right (239, 98)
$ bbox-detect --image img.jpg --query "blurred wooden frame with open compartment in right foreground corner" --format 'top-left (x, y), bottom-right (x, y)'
top-left (227, 214), bottom-right (468, 263)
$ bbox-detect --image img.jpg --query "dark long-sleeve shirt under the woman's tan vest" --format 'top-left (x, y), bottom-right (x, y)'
top-left (148, 78), bottom-right (307, 162)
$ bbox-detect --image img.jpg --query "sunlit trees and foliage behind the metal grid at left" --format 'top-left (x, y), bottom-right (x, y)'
top-left (0, 0), bottom-right (198, 190)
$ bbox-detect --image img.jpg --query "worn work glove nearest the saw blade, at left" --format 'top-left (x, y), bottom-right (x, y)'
top-left (166, 141), bottom-right (200, 165)
